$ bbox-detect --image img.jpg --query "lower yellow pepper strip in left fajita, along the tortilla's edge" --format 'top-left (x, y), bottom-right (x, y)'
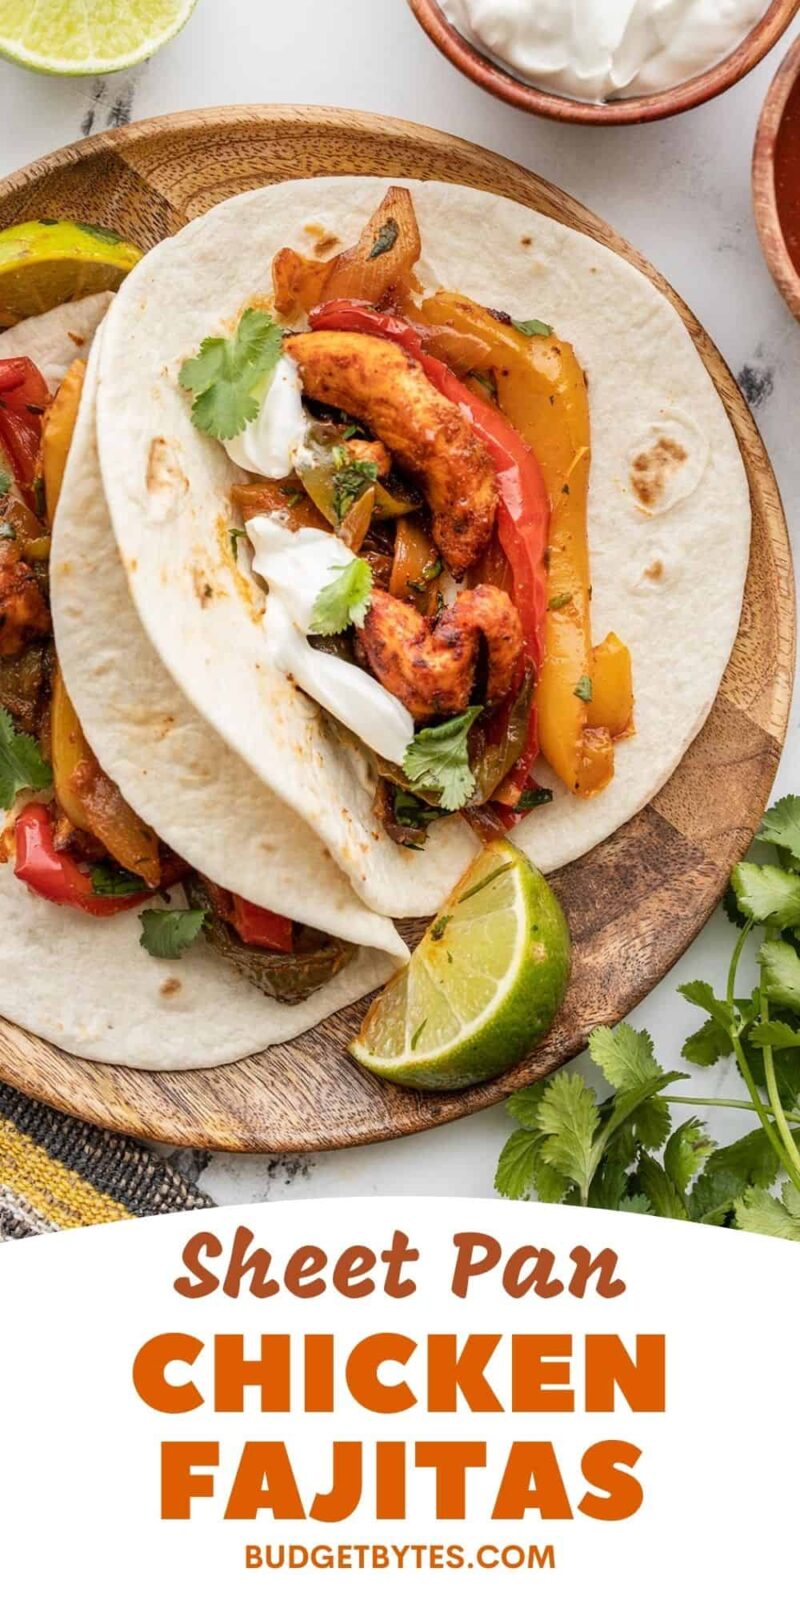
top-left (50, 667), bottom-right (162, 888)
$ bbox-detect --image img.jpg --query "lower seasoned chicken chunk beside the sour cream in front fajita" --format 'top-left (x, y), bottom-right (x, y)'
top-left (358, 584), bottom-right (523, 722)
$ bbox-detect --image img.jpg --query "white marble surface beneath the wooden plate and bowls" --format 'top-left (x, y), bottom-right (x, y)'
top-left (0, 0), bottom-right (800, 1203)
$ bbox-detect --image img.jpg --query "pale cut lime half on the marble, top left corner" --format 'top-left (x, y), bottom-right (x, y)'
top-left (0, 0), bottom-right (197, 75)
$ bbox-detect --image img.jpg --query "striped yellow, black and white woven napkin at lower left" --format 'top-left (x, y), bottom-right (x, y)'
top-left (0, 1083), bottom-right (213, 1240)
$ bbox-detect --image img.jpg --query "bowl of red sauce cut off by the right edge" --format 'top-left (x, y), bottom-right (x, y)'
top-left (752, 38), bottom-right (800, 322)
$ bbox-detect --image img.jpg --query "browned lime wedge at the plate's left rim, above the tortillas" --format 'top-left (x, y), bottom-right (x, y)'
top-left (0, 219), bottom-right (141, 328)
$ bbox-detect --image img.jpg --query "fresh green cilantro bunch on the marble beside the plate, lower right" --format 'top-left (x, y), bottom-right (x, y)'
top-left (496, 795), bottom-right (800, 1242)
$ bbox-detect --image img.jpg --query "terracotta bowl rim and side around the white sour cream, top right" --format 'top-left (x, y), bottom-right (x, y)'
top-left (408, 0), bottom-right (800, 126)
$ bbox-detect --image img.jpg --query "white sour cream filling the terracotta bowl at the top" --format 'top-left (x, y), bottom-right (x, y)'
top-left (440, 0), bottom-right (768, 101)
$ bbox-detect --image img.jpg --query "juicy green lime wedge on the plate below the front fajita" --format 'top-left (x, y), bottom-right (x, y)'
top-left (350, 840), bottom-right (571, 1090)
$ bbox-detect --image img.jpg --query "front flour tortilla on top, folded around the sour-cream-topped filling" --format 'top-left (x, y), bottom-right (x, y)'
top-left (98, 178), bottom-right (750, 917)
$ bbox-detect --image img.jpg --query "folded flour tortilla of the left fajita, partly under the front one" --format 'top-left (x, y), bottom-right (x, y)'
top-left (0, 307), bottom-right (406, 1070)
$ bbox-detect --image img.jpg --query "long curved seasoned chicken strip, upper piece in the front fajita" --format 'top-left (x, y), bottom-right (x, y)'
top-left (285, 331), bottom-right (498, 578)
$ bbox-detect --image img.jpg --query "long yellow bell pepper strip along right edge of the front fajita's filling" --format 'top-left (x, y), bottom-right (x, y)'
top-left (419, 291), bottom-right (632, 798)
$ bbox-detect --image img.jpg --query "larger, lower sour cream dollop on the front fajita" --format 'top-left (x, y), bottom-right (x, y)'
top-left (246, 517), bottom-right (414, 766)
